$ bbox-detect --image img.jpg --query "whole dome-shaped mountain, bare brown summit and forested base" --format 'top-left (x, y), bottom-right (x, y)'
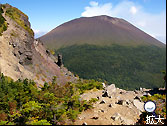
top-left (39, 16), bottom-right (166, 89)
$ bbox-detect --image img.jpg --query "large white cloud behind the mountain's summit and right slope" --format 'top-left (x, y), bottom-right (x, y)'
top-left (81, 0), bottom-right (166, 43)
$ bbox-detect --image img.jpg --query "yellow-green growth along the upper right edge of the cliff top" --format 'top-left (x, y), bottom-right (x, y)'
top-left (4, 5), bottom-right (34, 35)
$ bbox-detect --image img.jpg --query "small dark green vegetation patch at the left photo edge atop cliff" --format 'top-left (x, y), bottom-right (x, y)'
top-left (0, 4), bottom-right (7, 36)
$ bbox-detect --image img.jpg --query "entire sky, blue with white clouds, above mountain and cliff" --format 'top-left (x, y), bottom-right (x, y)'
top-left (0, 0), bottom-right (166, 43)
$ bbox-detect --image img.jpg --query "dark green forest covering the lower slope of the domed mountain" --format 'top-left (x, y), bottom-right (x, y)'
top-left (55, 45), bottom-right (166, 90)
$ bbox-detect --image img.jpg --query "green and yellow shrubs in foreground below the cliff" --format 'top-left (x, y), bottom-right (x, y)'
top-left (0, 74), bottom-right (102, 125)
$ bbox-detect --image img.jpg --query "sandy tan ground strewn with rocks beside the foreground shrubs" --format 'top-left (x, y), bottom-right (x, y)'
top-left (75, 84), bottom-right (151, 125)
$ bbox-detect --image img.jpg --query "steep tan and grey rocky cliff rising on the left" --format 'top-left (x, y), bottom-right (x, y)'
top-left (0, 4), bottom-right (76, 85)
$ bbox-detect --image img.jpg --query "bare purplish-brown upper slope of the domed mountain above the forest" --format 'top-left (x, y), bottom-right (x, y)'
top-left (40, 15), bottom-right (164, 49)
